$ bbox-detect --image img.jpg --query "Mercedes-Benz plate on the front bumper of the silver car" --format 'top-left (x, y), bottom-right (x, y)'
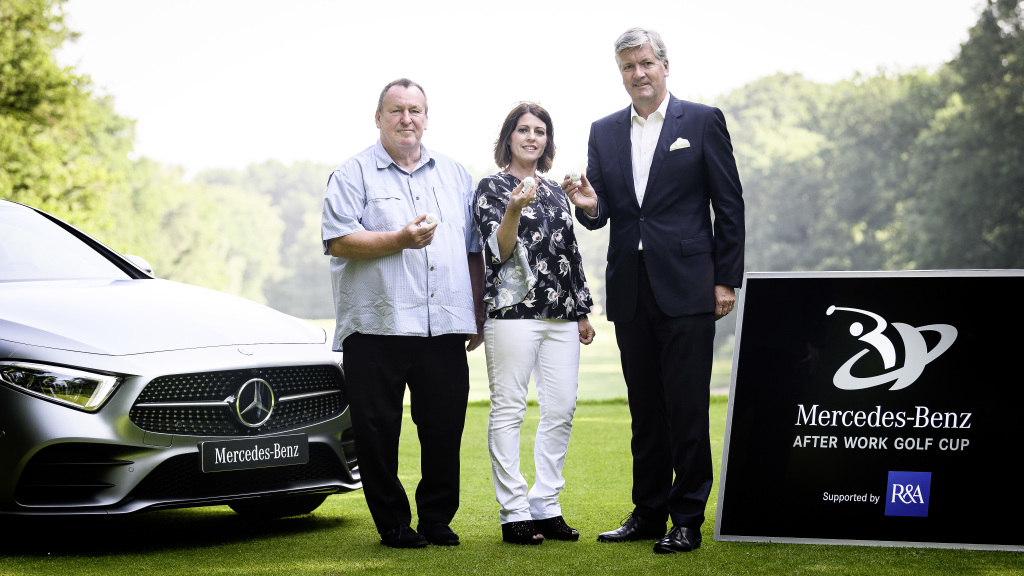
top-left (199, 434), bottom-right (309, 472)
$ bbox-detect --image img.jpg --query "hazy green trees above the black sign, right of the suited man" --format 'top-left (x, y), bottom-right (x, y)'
top-left (718, 0), bottom-right (1024, 271)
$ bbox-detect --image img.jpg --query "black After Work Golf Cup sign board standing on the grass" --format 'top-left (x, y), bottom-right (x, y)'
top-left (715, 271), bottom-right (1024, 550)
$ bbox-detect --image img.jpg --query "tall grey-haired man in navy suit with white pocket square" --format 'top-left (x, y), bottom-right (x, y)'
top-left (562, 28), bottom-right (744, 553)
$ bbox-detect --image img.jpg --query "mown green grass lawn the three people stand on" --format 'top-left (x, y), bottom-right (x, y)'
top-left (0, 396), bottom-right (1024, 576)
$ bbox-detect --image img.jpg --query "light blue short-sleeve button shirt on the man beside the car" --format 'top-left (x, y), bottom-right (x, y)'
top-left (321, 140), bottom-right (481, 351)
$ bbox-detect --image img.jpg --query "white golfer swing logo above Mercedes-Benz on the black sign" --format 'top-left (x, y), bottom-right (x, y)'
top-left (825, 305), bottom-right (956, 390)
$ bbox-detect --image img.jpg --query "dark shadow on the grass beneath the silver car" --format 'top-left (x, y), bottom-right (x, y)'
top-left (0, 507), bottom-right (346, 557)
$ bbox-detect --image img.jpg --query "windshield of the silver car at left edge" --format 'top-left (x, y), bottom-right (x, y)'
top-left (0, 202), bottom-right (130, 282)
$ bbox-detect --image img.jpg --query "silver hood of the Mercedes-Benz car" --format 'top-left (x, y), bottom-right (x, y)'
top-left (0, 279), bottom-right (326, 356)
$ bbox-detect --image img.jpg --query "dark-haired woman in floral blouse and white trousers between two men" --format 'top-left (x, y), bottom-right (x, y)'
top-left (475, 102), bottom-right (594, 544)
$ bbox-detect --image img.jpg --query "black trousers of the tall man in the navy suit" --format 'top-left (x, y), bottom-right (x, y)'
top-left (615, 251), bottom-right (715, 530)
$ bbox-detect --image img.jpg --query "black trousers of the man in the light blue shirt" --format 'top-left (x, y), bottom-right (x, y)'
top-left (342, 333), bottom-right (469, 534)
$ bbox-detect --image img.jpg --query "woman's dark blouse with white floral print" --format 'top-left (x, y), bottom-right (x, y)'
top-left (473, 172), bottom-right (594, 320)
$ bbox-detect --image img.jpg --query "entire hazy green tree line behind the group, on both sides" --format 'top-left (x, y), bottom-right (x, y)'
top-left (0, 0), bottom-right (1024, 318)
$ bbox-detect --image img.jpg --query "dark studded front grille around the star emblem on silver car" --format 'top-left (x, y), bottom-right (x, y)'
top-left (129, 366), bottom-right (347, 437)
